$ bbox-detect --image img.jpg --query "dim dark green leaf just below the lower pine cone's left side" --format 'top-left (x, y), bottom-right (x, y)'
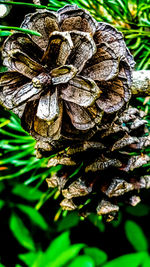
top-left (57, 212), bottom-right (80, 232)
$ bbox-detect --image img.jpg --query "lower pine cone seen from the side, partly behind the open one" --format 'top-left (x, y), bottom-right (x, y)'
top-left (47, 106), bottom-right (150, 221)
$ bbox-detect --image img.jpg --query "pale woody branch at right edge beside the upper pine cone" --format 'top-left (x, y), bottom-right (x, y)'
top-left (131, 70), bottom-right (150, 97)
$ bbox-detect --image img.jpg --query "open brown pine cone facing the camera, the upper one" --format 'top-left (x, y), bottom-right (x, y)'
top-left (0, 5), bottom-right (134, 150)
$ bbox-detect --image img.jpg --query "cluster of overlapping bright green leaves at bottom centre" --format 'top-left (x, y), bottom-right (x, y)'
top-left (19, 232), bottom-right (107, 267)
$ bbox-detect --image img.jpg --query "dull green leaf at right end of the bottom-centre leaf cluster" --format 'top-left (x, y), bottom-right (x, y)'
top-left (84, 247), bottom-right (107, 266)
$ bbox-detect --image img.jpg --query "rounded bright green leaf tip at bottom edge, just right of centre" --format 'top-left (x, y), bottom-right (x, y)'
top-left (68, 255), bottom-right (95, 267)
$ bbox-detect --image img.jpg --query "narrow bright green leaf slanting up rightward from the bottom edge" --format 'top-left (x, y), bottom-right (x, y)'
top-left (45, 243), bottom-right (85, 267)
